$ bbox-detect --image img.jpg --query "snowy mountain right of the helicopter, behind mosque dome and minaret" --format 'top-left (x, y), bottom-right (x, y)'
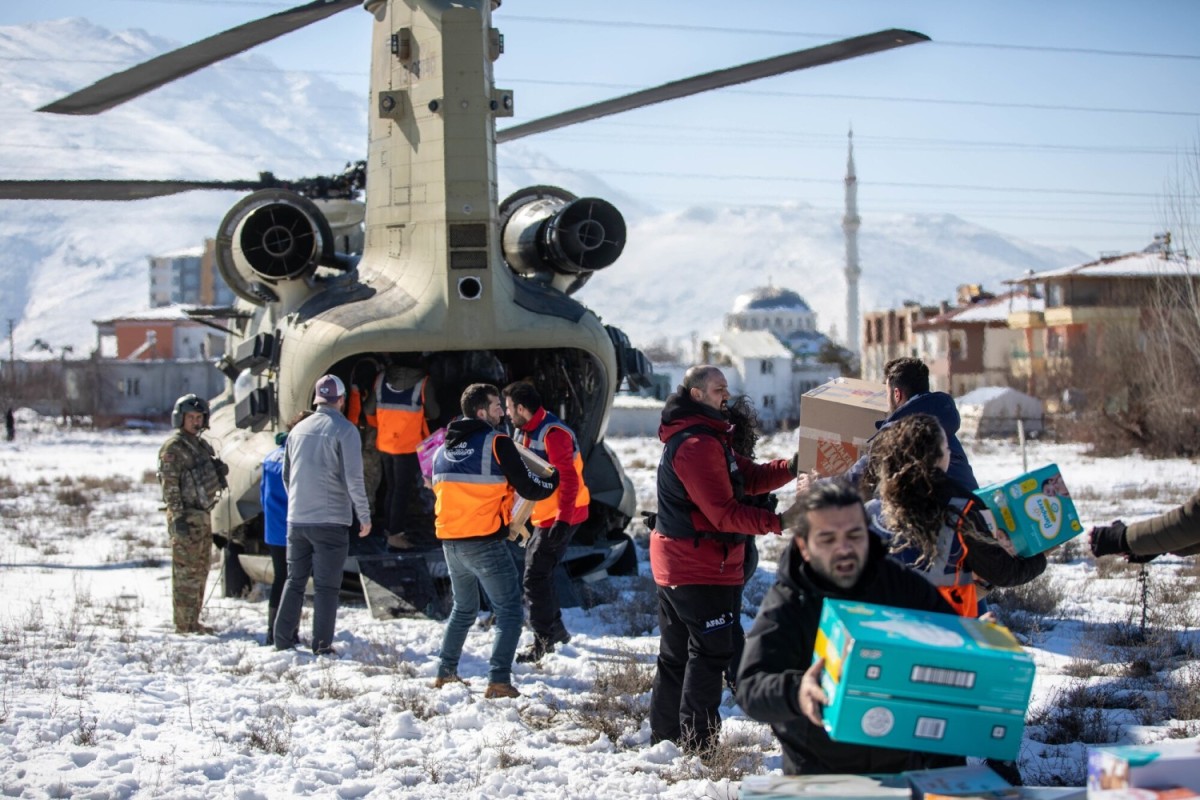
top-left (580, 204), bottom-right (1087, 347)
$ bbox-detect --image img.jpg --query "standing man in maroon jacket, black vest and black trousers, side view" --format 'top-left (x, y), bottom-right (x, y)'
top-left (650, 365), bottom-right (796, 754)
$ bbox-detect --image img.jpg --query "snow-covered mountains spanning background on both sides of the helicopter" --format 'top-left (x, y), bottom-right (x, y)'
top-left (0, 19), bottom-right (1086, 354)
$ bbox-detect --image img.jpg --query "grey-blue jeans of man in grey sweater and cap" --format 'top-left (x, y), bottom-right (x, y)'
top-left (272, 524), bottom-right (350, 652)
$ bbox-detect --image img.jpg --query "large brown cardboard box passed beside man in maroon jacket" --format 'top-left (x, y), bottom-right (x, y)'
top-left (797, 378), bottom-right (888, 475)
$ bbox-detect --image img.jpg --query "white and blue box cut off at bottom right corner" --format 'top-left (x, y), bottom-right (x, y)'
top-left (1087, 740), bottom-right (1200, 800)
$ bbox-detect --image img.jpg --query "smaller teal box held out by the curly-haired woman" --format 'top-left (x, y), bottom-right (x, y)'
top-left (976, 464), bottom-right (1084, 557)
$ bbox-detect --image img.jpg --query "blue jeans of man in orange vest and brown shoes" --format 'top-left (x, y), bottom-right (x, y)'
top-left (438, 539), bottom-right (524, 684)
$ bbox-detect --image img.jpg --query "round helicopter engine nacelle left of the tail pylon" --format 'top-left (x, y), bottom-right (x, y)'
top-left (216, 190), bottom-right (344, 305)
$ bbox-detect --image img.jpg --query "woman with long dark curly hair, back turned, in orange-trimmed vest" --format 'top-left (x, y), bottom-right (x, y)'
top-left (860, 414), bottom-right (1046, 616)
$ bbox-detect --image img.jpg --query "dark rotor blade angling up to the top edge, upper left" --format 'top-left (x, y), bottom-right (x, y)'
top-left (37, 0), bottom-right (361, 114)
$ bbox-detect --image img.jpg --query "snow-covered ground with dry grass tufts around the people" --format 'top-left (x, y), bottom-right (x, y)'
top-left (0, 420), bottom-right (1200, 800)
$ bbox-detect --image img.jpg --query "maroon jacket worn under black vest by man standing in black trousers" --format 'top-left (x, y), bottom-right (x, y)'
top-left (650, 396), bottom-right (793, 587)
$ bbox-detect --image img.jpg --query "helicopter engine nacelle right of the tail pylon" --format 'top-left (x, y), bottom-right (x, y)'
top-left (500, 186), bottom-right (625, 294)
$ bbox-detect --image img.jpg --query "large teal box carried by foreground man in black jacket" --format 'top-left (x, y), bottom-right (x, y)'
top-left (812, 600), bottom-right (1034, 759)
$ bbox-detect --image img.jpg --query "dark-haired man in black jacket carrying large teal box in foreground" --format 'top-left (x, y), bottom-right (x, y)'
top-left (737, 481), bottom-right (964, 775)
